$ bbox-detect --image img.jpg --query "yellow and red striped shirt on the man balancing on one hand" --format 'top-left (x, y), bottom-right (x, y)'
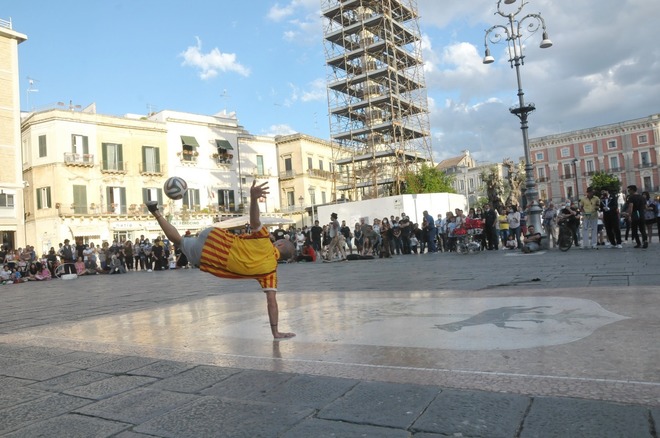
top-left (199, 227), bottom-right (280, 290)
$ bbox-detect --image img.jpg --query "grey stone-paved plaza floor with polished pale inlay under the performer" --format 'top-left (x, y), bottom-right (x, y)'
top-left (0, 245), bottom-right (660, 438)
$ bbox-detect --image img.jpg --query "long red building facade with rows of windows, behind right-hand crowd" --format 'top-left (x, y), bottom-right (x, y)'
top-left (530, 114), bottom-right (660, 202)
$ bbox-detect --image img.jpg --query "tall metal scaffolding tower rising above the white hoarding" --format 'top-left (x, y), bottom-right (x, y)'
top-left (322, 0), bottom-right (433, 200)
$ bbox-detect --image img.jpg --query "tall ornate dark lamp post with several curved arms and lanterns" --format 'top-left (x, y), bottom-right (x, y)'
top-left (483, 0), bottom-right (552, 236)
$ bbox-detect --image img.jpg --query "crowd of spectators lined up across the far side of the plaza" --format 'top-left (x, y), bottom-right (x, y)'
top-left (0, 185), bottom-right (660, 284)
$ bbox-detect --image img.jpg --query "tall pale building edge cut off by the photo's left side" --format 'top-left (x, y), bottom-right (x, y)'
top-left (0, 19), bottom-right (27, 249)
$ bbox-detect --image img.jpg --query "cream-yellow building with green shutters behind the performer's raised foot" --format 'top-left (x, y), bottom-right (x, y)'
top-left (22, 105), bottom-right (167, 254)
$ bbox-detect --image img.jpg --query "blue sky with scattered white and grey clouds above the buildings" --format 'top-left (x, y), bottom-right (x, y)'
top-left (0, 0), bottom-right (660, 162)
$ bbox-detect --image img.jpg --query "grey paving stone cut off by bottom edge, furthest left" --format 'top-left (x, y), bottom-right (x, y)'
top-left (5, 414), bottom-right (132, 438)
